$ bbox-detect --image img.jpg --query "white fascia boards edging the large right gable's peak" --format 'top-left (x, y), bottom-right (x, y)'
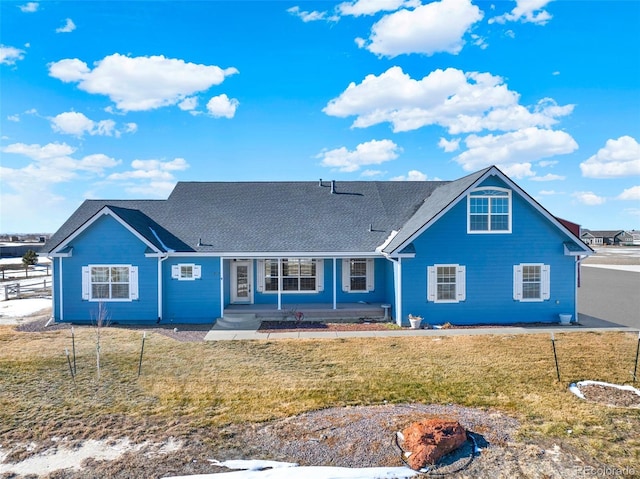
top-left (390, 166), bottom-right (594, 257)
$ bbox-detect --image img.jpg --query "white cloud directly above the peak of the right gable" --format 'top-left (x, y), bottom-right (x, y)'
top-left (454, 127), bottom-right (578, 178)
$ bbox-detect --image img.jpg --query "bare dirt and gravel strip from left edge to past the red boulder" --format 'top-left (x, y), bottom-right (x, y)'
top-left (0, 404), bottom-right (591, 479)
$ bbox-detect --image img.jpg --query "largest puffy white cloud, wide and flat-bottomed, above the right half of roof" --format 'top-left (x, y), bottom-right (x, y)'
top-left (323, 66), bottom-right (573, 134)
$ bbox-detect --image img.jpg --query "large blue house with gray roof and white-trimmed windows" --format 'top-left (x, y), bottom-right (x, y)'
top-left (44, 167), bottom-right (593, 325)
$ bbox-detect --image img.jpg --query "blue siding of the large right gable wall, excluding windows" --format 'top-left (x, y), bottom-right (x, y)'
top-left (402, 178), bottom-right (576, 324)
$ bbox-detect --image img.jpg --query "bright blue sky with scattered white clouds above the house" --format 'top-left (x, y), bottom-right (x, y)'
top-left (0, 0), bottom-right (640, 233)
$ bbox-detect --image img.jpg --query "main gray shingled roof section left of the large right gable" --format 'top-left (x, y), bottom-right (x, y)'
top-left (44, 181), bottom-right (448, 253)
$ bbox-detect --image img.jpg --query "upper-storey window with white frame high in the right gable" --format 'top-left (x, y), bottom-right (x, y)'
top-left (467, 186), bottom-right (511, 233)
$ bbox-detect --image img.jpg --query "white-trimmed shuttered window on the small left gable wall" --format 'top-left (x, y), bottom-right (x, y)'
top-left (82, 264), bottom-right (138, 301)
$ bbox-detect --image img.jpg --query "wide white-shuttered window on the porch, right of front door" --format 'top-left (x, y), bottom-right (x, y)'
top-left (258, 258), bottom-right (324, 293)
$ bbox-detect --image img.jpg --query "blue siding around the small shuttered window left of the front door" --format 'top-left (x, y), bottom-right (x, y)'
top-left (162, 256), bottom-right (220, 323)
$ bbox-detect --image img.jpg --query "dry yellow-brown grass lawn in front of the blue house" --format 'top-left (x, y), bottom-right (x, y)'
top-left (0, 327), bottom-right (640, 467)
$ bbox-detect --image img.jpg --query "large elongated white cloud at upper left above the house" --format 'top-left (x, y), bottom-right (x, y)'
top-left (49, 53), bottom-right (238, 111)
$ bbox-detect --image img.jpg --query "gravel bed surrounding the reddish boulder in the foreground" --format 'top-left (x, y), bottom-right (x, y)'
top-left (218, 404), bottom-right (589, 479)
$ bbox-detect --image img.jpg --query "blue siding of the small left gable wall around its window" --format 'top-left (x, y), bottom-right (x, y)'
top-left (54, 215), bottom-right (158, 323)
